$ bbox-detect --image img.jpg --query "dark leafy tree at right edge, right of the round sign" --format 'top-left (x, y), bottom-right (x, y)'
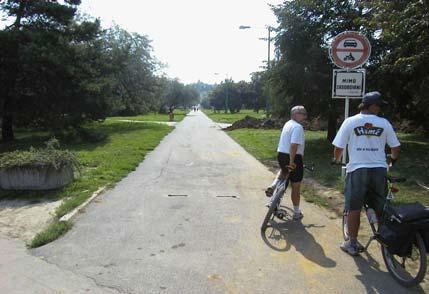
top-left (363, 0), bottom-right (429, 131)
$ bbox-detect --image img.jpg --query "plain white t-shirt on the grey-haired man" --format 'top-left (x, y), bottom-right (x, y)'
top-left (277, 119), bottom-right (305, 155)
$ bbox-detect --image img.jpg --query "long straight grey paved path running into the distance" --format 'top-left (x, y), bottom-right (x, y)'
top-left (23, 112), bottom-right (422, 293)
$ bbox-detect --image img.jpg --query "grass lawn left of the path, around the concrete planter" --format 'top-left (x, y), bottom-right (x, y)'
top-left (0, 120), bottom-right (172, 247)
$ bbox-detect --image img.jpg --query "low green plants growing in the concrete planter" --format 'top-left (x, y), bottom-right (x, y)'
top-left (0, 138), bottom-right (80, 169)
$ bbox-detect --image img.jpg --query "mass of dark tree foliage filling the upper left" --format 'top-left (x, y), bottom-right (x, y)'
top-left (0, 0), bottom-right (160, 140)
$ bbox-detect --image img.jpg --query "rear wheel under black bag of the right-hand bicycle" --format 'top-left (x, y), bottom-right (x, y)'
top-left (381, 232), bottom-right (427, 287)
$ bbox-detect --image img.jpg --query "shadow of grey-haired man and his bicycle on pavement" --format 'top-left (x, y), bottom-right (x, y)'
top-left (261, 207), bottom-right (337, 268)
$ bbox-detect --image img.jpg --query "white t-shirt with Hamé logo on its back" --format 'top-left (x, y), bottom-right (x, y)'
top-left (332, 113), bottom-right (401, 173)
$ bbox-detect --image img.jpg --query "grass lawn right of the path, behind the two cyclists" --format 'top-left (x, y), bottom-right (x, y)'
top-left (228, 129), bottom-right (429, 205)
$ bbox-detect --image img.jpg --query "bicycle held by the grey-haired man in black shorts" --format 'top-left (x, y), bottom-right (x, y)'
top-left (261, 164), bottom-right (314, 232)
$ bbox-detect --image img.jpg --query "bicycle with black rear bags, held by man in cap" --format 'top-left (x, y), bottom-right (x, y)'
top-left (342, 172), bottom-right (429, 287)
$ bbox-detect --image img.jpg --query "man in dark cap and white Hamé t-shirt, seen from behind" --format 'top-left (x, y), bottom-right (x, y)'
top-left (332, 92), bottom-right (400, 256)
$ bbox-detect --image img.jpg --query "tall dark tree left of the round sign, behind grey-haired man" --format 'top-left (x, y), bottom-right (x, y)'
top-left (268, 0), bottom-right (362, 139)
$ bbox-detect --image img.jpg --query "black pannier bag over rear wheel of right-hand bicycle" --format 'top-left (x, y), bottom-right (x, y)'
top-left (378, 202), bottom-right (429, 256)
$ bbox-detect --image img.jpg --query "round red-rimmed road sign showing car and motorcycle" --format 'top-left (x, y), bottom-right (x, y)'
top-left (329, 31), bottom-right (371, 68)
